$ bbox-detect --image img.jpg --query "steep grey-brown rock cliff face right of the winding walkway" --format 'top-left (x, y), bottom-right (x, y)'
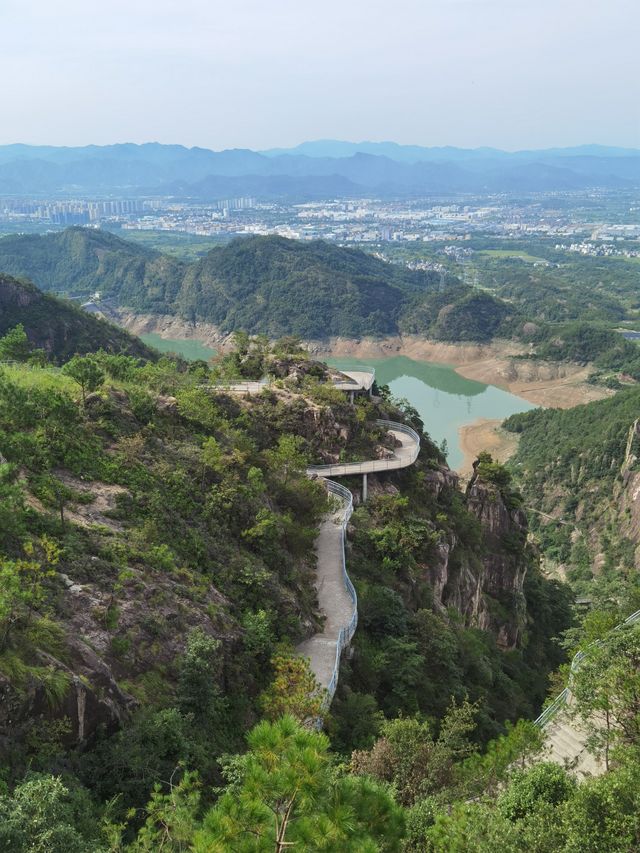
top-left (427, 471), bottom-right (531, 649)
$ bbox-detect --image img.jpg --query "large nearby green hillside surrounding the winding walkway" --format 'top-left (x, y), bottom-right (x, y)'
top-left (0, 316), bottom-right (604, 853)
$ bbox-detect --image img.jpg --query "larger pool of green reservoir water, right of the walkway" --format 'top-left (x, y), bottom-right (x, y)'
top-left (327, 356), bottom-right (536, 468)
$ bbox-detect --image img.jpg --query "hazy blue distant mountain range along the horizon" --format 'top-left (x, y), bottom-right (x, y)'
top-left (0, 140), bottom-right (640, 201)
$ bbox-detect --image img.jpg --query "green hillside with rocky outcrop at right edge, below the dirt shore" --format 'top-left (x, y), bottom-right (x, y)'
top-left (504, 388), bottom-right (640, 609)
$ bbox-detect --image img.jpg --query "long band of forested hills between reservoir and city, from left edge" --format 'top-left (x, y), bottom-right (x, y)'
top-left (0, 228), bottom-right (518, 341)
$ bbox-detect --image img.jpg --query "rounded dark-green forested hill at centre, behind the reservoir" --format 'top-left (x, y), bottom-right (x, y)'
top-left (177, 237), bottom-right (439, 338)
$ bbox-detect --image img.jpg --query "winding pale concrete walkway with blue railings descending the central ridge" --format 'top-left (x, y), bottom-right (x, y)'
top-left (296, 421), bottom-right (420, 704)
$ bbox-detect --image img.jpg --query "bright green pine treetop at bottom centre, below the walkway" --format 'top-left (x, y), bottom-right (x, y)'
top-left (194, 717), bottom-right (403, 853)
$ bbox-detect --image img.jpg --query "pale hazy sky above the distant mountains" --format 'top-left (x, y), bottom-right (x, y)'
top-left (0, 0), bottom-right (640, 149)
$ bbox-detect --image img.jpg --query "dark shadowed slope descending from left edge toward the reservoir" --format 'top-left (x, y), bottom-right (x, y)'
top-left (0, 273), bottom-right (155, 362)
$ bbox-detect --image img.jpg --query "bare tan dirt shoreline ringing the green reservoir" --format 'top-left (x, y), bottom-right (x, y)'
top-left (118, 311), bottom-right (613, 474)
